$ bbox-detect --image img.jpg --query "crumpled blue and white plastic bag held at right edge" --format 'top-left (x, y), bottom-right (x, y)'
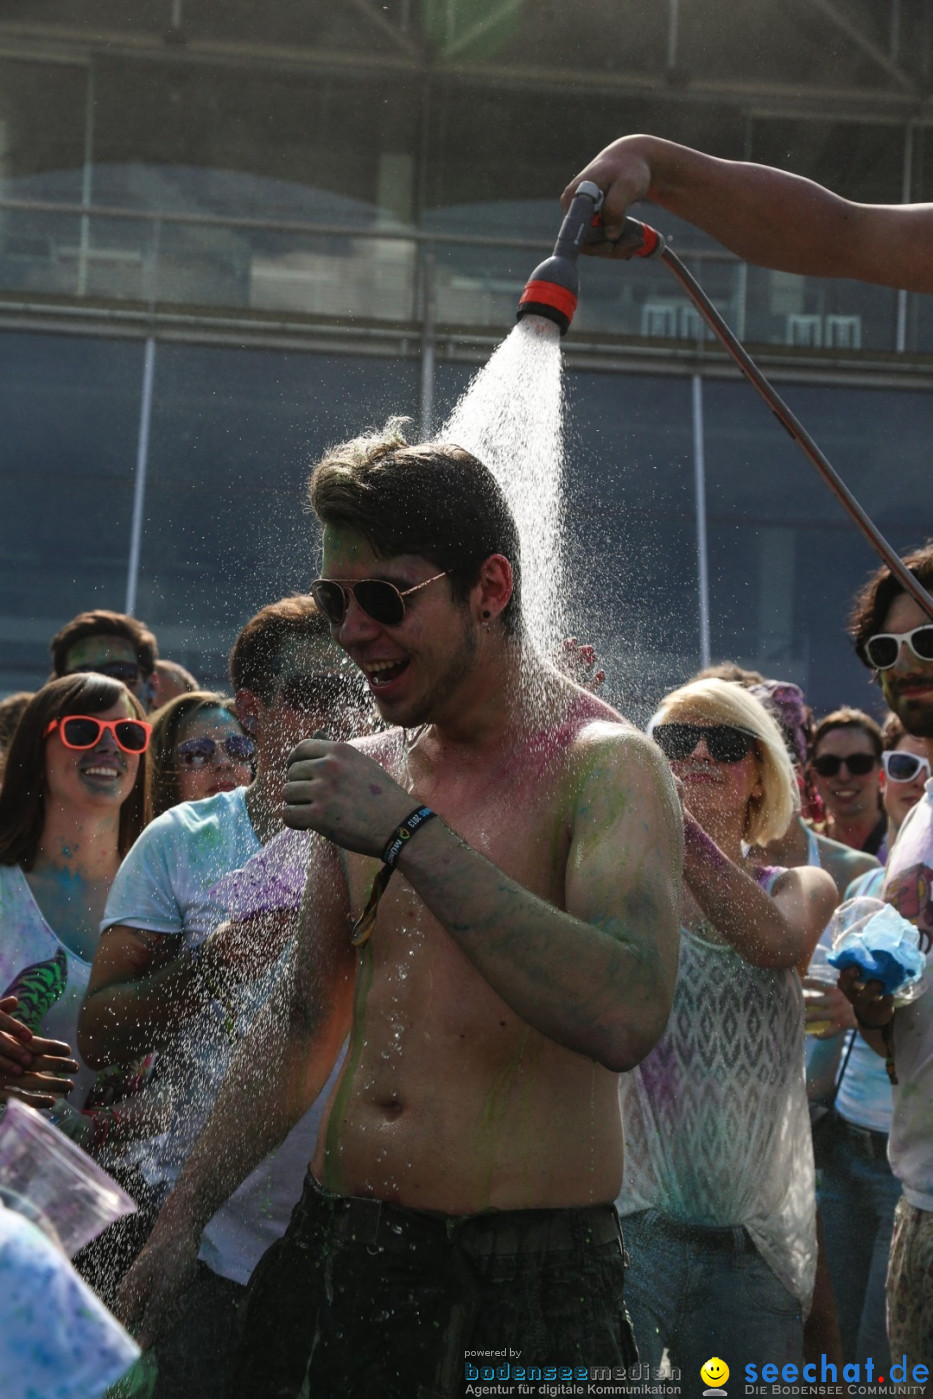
top-left (827, 898), bottom-right (926, 1004)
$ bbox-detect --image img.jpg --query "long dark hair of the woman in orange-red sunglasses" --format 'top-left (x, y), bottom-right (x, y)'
top-left (0, 672), bottom-right (150, 870)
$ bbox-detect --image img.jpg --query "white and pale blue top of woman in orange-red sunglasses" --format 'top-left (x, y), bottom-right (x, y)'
top-left (0, 865), bottom-right (97, 1108)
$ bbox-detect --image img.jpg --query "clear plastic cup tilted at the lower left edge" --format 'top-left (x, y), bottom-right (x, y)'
top-left (0, 1098), bottom-right (136, 1258)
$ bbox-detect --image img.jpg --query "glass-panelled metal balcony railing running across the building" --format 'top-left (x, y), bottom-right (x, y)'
top-left (0, 199), bottom-right (917, 357)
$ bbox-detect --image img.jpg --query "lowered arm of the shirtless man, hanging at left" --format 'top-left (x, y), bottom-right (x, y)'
top-left (116, 842), bottom-right (355, 1347)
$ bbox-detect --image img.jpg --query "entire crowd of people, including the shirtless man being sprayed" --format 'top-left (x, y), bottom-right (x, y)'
top-left (0, 143), bottom-right (933, 1399)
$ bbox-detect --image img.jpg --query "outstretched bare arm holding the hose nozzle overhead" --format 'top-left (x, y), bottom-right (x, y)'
top-left (562, 136), bottom-right (933, 292)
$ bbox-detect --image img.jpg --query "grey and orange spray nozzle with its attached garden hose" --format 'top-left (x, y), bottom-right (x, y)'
top-left (518, 197), bottom-right (933, 618)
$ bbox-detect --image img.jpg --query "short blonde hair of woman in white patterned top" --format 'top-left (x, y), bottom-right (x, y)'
top-left (648, 680), bottom-right (800, 845)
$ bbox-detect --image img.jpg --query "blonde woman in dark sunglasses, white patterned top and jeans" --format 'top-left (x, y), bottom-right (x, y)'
top-left (618, 680), bottom-right (838, 1375)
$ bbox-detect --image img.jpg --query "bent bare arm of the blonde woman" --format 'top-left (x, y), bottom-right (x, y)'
top-left (684, 811), bottom-right (838, 970)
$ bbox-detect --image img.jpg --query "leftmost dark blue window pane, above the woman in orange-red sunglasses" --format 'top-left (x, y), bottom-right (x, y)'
top-left (0, 333), bottom-right (143, 691)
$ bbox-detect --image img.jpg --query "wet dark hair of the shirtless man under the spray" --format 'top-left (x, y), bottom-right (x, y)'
top-left (309, 418), bottom-right (522, 634)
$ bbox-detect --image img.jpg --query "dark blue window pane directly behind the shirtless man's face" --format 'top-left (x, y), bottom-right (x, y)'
top-left (138, 346), bottom-right (417, 684)
